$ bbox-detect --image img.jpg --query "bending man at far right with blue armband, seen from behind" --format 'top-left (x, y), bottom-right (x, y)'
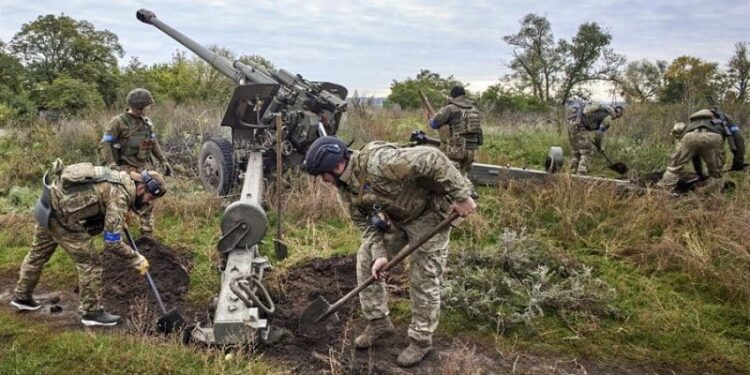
top-left (658, 109), bottom-right (746, 191)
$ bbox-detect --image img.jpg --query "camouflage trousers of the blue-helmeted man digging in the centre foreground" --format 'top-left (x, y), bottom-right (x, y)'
top-left (357, 210), bottom-right (450, 341)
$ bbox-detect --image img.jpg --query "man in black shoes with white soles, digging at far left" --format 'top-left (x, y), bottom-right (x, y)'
top-left (11, 159), bottom-right (166, 326)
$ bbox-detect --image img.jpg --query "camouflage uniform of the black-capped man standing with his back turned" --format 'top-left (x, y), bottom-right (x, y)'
top-left (430, 95), bottom-right (476, 176)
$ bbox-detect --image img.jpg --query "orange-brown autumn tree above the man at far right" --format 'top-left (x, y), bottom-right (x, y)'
top-left (659, 56), bottom-right (719, 104)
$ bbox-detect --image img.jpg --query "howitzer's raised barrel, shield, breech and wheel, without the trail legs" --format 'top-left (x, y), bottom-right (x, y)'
top-left (136, 9), bottom-right (347, 195)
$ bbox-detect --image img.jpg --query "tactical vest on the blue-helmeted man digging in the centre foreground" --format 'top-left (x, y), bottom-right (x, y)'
top-left (352, 142), bottom-right (429, 223)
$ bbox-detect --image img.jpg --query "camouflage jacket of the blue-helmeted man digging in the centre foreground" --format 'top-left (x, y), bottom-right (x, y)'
top-left (339, 142), bottom-right (471, 258)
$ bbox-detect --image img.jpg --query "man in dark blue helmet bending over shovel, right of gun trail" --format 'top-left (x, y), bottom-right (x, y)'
top-left (304, 137), bottom-right (476, 367)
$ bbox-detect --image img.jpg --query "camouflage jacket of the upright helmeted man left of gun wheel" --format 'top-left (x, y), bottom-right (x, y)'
top-left (100, 112), bottom-right (165, 169)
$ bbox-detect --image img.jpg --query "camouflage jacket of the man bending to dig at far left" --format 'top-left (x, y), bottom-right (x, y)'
top-left (50, 167), bottom-right (142, 258)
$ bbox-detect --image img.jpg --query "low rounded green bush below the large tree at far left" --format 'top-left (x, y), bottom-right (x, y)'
top-left (34, 75), bottom-right (104, 115)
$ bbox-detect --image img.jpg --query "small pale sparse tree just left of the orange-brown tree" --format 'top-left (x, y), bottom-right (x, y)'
top-left (616, 59), bottom-right (667, 103)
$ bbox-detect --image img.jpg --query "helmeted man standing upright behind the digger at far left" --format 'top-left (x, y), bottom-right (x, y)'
top-left (99, 89), bottom-right (172, 238)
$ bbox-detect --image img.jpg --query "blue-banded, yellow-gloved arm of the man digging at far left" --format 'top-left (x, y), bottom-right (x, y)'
top-left (102, 184), bottom-right (138, 259)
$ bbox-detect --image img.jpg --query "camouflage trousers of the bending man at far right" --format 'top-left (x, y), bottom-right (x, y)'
top-left (658, 129), bottom-right (724, 189)
